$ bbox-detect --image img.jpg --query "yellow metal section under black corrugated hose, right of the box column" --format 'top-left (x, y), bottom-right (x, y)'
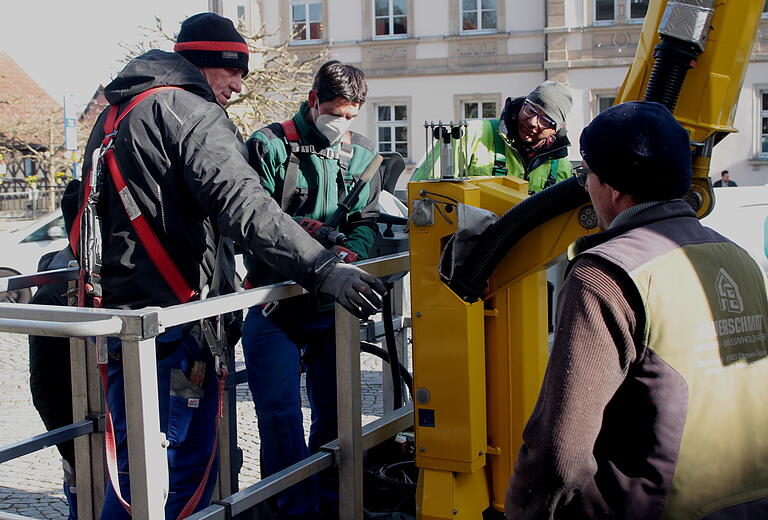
top-left (486, 204), bottom-right (588, 510)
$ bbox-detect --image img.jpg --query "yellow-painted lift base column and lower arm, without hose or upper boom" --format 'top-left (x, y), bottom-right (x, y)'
top-left (408, 177), bottom-right (596, 520)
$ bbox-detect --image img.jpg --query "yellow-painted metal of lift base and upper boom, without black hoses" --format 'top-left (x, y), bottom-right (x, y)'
top-left (408, 0), bottom-right (764, 520)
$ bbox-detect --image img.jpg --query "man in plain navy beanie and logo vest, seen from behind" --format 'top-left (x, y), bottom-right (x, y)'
top-left (505, 102), bottom-right (768, 520)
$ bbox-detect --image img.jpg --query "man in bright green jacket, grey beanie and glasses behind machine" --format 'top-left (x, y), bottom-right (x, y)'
top-left (411, 81), bottom-right (571, 193)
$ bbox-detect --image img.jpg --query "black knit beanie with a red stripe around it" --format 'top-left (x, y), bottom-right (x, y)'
top-left (173, 13), bottom-right (248, 76)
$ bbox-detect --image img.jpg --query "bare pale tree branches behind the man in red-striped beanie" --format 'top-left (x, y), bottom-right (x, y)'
top-left (123, 17), bottom-right (327, 136)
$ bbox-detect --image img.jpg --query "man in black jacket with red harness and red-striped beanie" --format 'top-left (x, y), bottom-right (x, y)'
top-left (78, 13), bottom-right (384, 520)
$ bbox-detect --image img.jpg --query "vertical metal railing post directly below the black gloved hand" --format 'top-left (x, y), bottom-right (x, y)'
top-left (336, 305), bottom-right (363, 520)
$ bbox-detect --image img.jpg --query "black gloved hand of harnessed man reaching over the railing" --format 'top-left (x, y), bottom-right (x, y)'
top-left (317, 263), bottom-right (386, 320)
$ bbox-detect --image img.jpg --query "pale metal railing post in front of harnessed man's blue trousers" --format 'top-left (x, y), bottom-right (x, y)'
top-left (122, 338), bottom-right (168, 520)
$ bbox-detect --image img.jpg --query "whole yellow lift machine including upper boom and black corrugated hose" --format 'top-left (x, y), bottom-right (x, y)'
top-left (408, 0), bottom-right (765, 520)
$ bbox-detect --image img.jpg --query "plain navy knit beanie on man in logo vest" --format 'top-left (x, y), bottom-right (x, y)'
top-left (579, 101), bottom-right (691, 200)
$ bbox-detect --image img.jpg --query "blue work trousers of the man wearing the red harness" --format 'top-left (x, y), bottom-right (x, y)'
top-left (101, 327), bottom-right (218, 520)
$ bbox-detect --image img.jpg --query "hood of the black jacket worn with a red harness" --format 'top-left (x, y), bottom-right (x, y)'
top-left (104, 50), bottom-right (216, 105)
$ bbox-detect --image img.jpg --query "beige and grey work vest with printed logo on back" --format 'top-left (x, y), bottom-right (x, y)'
top-left (582, 207), bottom-right (768, 520)
